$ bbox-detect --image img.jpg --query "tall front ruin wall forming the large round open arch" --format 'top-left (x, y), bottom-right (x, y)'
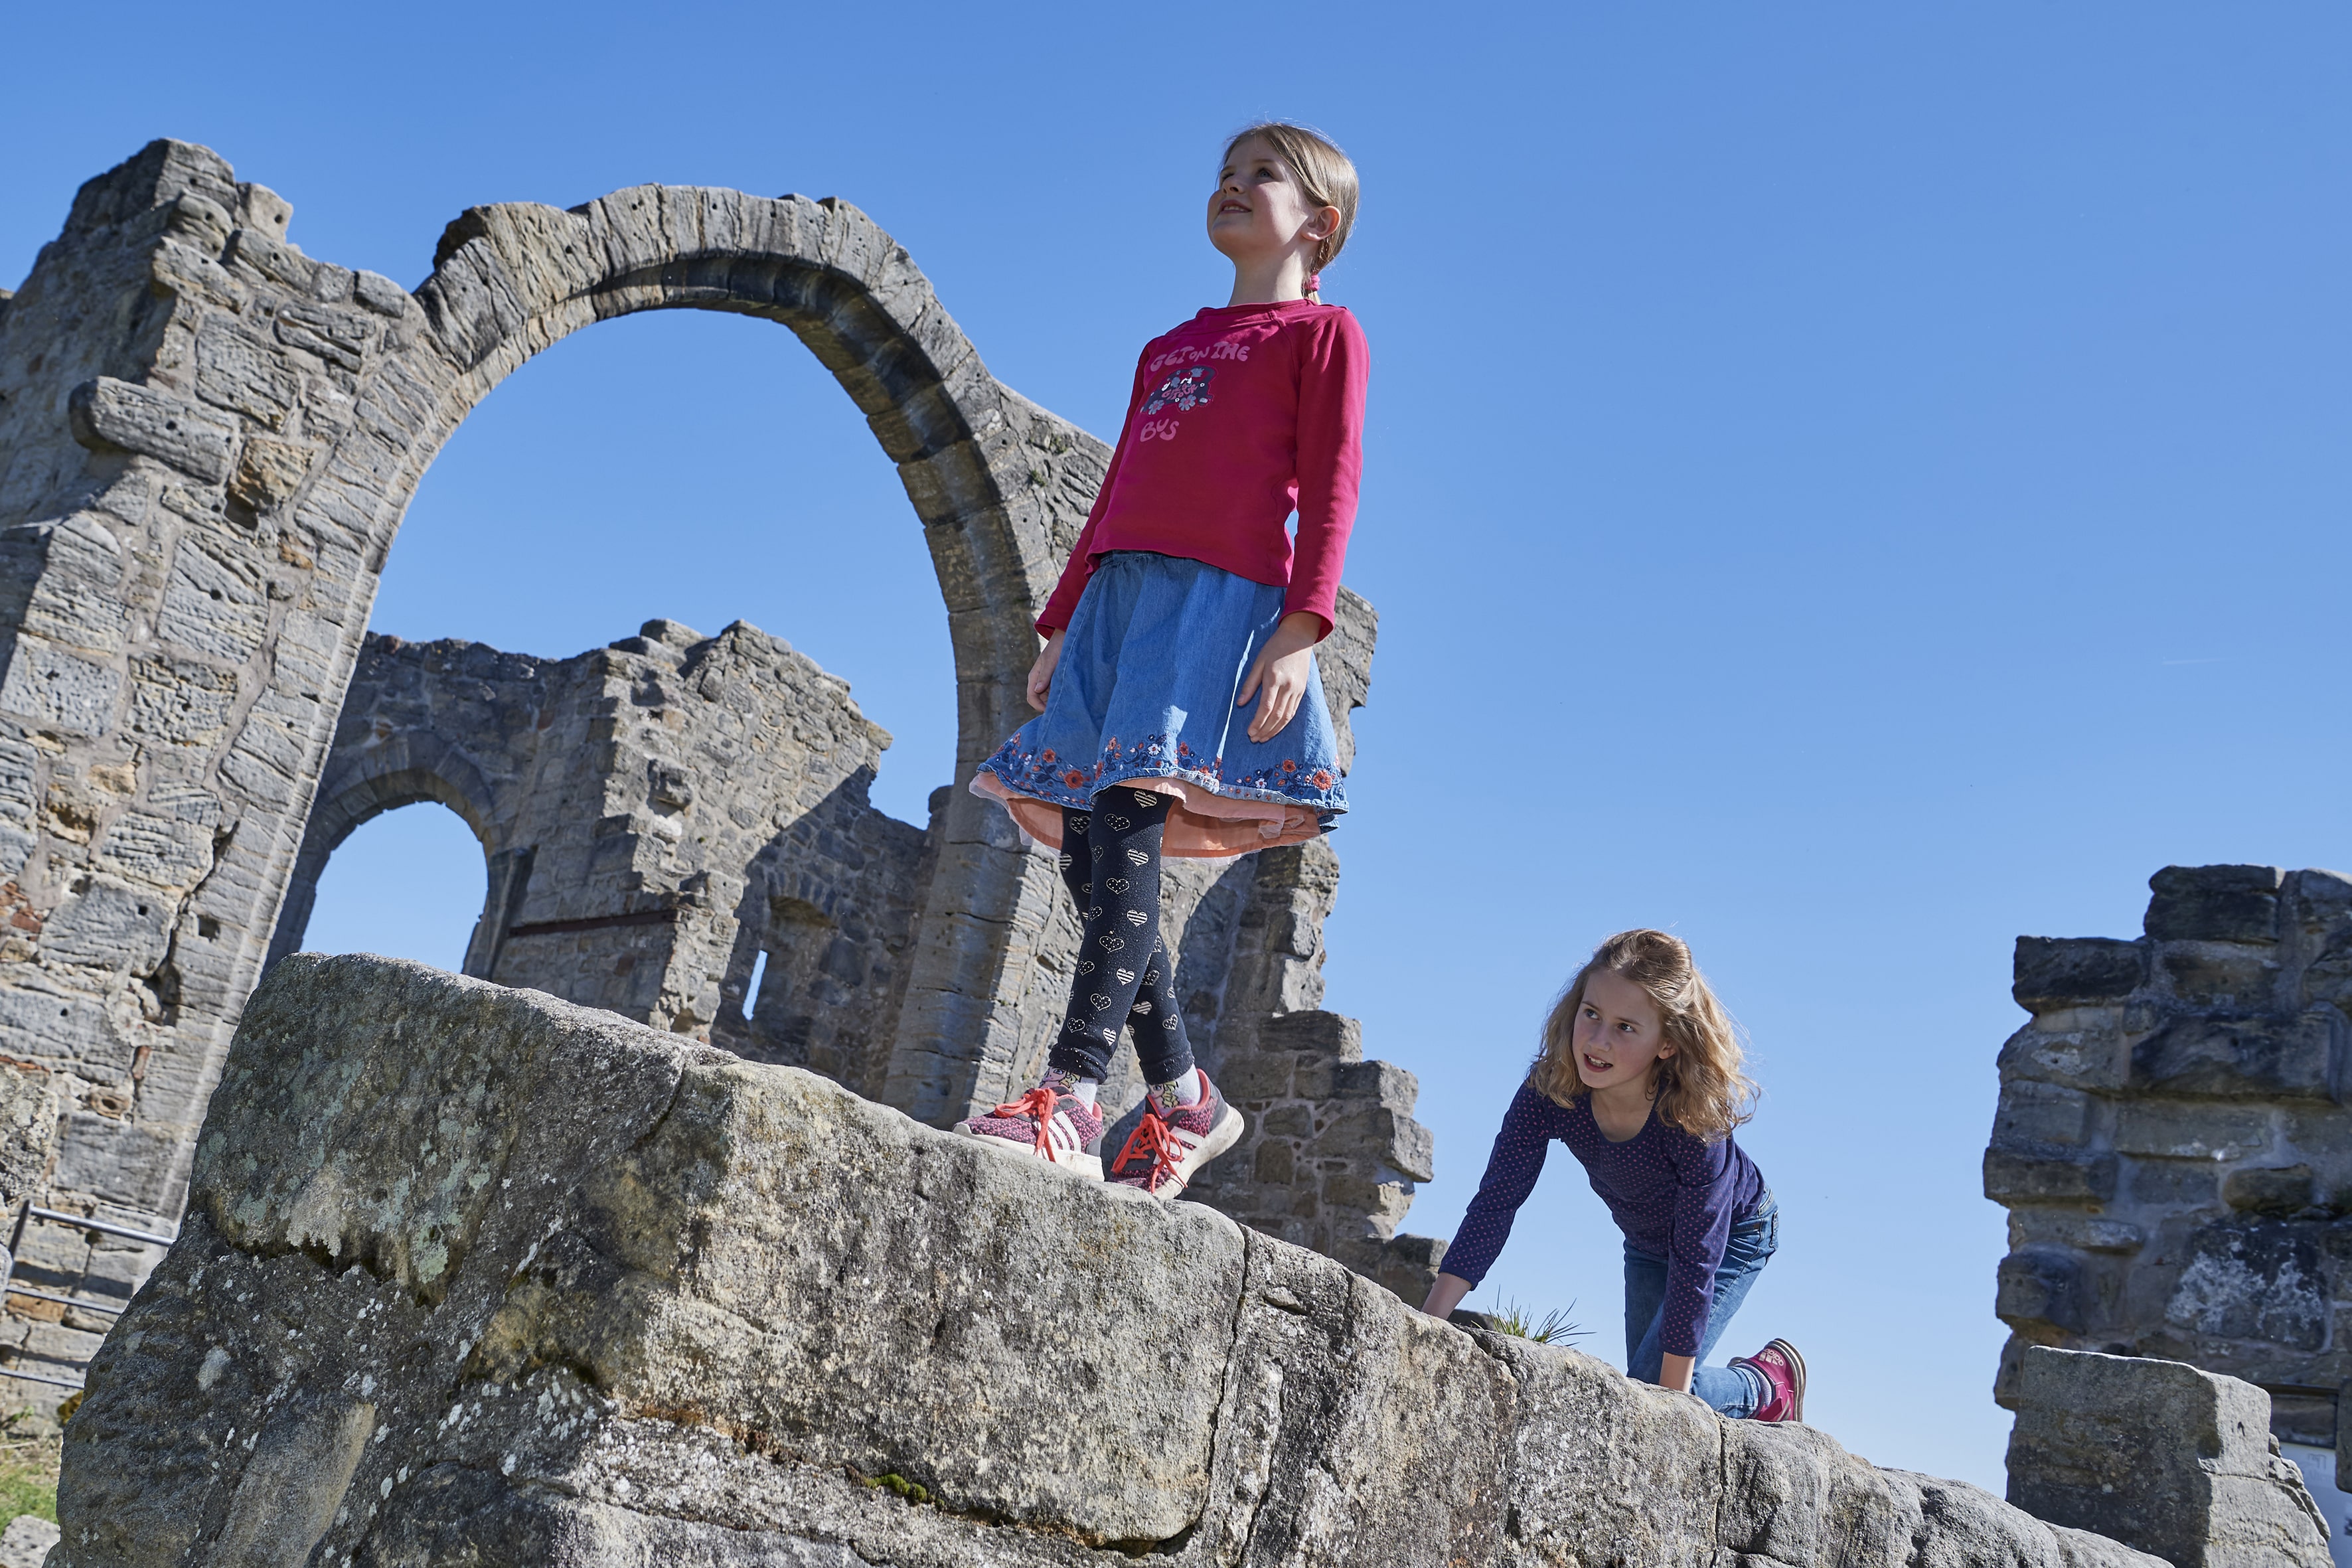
top-left (0, 143), bottom-right (1103, 1215)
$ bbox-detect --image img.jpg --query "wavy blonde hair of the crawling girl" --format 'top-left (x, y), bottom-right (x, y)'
top-left (1526, 931), bottom-right (1757, 1142)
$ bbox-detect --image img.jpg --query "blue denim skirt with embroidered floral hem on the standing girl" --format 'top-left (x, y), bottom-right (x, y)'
top-left (971, 550), bottom-right (1348, 858)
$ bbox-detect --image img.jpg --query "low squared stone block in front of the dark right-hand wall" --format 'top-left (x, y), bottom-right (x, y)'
top-left (2009, 1345), bottom-right (2331, 1568)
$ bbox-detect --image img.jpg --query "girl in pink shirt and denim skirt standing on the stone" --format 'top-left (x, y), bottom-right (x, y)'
top-left (955, 125), bottom-right (1366, 1196)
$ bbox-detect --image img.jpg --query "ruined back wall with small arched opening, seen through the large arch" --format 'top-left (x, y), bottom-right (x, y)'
top-left (273, 621), bottom-right (929, 1089)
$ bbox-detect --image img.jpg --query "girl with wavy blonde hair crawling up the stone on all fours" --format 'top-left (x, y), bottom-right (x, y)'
top-left (1421, 931), bottom-right (1804, 1420)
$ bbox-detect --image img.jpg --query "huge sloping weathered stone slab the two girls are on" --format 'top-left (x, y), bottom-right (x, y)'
top-left (52, 955), bottom-right (2154, 1568)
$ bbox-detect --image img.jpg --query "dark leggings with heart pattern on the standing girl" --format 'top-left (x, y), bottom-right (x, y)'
top-left (1047, 785), bottom-right (1192, 1084)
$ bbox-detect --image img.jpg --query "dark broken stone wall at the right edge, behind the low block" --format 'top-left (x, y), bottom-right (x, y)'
top-left (1985, 865), bottom-right (2352, 1474)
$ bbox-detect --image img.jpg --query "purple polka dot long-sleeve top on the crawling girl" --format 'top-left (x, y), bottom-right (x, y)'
top-left (1439, 1084), bottom-right (1764, 1356)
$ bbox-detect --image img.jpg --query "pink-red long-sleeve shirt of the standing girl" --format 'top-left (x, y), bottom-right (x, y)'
top-left (1037, 299), bottom-right (1369, 635)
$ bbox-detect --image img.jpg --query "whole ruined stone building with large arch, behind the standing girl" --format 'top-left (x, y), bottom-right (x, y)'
top-left (0, 128), bottom-right (1437, 1361)
